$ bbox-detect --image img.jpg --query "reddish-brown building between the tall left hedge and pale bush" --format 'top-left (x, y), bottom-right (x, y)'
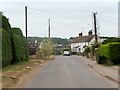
top-left (28, 40), bottom-right (41, 55)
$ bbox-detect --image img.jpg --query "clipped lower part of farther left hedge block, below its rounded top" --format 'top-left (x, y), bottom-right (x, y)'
top-left (12, 34), bottom-right (28, 63)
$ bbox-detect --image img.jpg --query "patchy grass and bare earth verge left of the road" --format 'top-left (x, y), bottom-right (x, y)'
top-left (2, 60), bottom-right (41, 88)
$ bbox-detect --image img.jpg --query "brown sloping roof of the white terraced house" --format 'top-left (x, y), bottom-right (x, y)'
top-left (72, 35), bottom-right (95, 43)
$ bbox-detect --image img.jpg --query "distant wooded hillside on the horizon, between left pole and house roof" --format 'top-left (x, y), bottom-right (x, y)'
top-left (28, 37), bottom-right (71, 45)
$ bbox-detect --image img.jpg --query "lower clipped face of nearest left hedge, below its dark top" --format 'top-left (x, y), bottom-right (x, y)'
top-left (2, 29), bottom-right (12, 66)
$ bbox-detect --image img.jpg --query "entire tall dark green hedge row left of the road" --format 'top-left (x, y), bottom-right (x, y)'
top-left (0, 15), bottom-right (29, 67)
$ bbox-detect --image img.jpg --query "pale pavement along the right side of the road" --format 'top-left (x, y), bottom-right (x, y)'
top-left (79, 56), bottom-right (118, 83)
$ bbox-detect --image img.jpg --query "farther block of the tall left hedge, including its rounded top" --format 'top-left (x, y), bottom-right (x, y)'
top-left (11, 28), bottom-right (29, 63)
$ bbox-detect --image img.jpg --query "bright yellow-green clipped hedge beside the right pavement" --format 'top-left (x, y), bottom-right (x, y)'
top-left (95, 42), bottom-right (120, 64)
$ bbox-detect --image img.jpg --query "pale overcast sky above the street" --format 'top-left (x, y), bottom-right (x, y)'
top-left (0, 0), bottom-right (118, 38)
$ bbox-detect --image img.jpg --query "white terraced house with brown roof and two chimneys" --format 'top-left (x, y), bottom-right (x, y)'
top-left (71, 30), bottom-right (100, 53)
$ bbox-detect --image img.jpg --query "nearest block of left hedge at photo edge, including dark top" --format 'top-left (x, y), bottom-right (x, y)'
top-left (0, 12), bottom-right (12, 67)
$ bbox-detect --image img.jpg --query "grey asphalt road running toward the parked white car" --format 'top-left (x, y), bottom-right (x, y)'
top-left (26, 56), bottom-right (118, 88)
